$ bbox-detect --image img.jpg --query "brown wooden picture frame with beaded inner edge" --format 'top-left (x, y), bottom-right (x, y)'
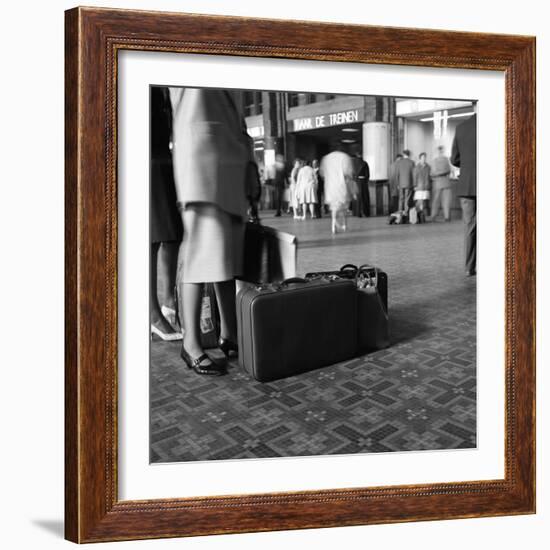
top-left (65, 8), bottom-right (535, 543)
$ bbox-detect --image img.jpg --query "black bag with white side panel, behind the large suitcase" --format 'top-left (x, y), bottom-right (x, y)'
top-left (244, 222), bottom-right (298, 283)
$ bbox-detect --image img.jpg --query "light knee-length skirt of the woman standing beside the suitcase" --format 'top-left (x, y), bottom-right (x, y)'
top-left (180, 203), bottom-right (245, 283)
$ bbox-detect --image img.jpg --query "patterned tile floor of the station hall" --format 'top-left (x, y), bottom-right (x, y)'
top-left (150, 211), bottom-right (476, 463)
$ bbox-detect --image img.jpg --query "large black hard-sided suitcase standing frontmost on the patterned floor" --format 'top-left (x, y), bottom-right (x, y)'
top-left (237, 279), bottom-right (358, 382)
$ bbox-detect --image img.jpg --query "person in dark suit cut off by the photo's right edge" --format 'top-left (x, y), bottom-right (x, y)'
top-left (451, 113), bottom-right (477, 276)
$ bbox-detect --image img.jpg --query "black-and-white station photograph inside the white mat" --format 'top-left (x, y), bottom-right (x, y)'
top-left (150, 85), bottom-right (477, 463)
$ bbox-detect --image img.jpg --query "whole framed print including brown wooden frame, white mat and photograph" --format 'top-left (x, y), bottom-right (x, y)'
top-left (65, 8), bottom-right (535, 542)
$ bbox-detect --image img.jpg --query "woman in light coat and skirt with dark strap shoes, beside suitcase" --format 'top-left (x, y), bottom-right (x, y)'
top-left (170, 88), bottom-right (260, 375)
